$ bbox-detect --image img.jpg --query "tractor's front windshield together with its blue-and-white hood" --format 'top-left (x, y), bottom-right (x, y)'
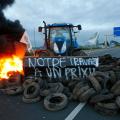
top-left (50, 27), bottom-right (70, 54)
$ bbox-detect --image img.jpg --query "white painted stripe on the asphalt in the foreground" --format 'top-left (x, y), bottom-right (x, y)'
top-left (65, 103), bottom-right (86, 120)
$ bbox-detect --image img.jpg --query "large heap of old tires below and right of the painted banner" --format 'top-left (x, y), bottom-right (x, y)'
top-left (0, 55), bottom-right (120, 115)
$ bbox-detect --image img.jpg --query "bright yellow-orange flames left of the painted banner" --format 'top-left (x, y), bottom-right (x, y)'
top-left (0, 55), bottom-right (23, 80)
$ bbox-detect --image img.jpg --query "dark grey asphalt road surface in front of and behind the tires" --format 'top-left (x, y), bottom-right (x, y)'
top-left (0, 48), bottom-right (120, 120)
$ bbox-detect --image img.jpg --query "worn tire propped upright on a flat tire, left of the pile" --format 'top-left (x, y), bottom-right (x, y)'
top-left (24, 82), bottom-right (40, 99)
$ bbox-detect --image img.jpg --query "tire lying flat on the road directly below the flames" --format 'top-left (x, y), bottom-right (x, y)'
top-left (5, 86), bottom-right (23, 95)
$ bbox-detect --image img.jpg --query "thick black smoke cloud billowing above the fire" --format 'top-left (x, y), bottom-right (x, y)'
top-left (0, 0), bottom-right (25, 41)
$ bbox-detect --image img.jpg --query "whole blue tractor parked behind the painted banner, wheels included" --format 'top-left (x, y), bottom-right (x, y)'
top-left (35, 21), bottom-right (86, 56)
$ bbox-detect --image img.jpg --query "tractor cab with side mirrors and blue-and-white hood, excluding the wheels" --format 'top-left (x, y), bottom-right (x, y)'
top-left (39, 22), bottom-right (81, 56)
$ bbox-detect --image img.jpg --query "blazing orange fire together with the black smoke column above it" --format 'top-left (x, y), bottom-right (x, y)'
top-left (0, 0), bottom-right (26, 81)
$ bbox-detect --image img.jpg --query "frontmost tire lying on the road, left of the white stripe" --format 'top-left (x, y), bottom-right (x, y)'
top-left (44, 93), bottom-right (68, 111)
